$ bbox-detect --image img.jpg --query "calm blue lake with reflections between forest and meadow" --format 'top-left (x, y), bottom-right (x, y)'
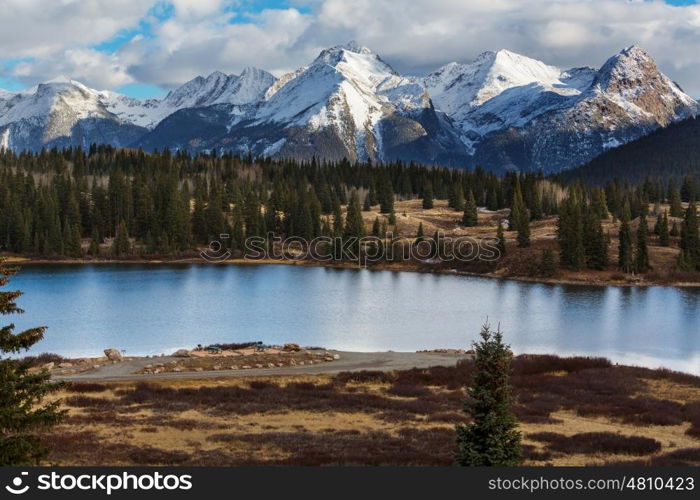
top-left (2, 264), bottom-right (700, 374)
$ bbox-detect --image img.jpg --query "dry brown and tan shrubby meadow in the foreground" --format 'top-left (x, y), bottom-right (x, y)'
top-left (46, 356), bottom-right (700, 465)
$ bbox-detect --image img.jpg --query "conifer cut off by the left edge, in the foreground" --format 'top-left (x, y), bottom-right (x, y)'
top-left (0, 260), bottom-right (63, 466)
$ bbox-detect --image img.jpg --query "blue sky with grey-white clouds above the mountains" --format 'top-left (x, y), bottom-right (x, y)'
top-left (0, 0), bottom-right (700, 97)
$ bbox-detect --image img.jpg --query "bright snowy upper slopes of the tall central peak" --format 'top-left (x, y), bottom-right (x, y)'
top-left (252, 42), bottom-right (430, 158)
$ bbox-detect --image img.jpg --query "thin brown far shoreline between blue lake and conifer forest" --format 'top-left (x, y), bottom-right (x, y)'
top-left (4, 256), bottom-right (700, 288)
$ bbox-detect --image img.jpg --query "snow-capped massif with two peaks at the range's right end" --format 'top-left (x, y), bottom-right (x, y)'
top-left (425, 46), bottom-right (698, 172)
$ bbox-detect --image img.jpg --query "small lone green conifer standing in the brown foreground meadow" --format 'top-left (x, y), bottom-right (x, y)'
top-left (455, 323), bottom-right (522, 466)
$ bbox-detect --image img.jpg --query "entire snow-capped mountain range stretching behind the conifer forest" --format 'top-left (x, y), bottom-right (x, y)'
top-left (0, 42), bottom-right (699, 172)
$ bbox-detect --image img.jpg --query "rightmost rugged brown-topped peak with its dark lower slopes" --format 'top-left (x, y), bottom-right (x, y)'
top-left (464, 46), bottom-right (698, 172)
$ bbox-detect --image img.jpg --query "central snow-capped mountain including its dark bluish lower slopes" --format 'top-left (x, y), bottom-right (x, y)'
top-left (141, 43), bottom-right (465, 164)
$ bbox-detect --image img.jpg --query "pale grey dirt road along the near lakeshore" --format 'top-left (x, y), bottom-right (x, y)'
top-left (53, 350), bottom-right (469, 382)
